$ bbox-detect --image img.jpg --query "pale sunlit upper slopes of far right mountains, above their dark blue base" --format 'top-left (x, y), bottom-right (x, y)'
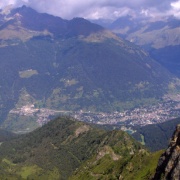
top-left (109, 16), bottom-right (180, 49)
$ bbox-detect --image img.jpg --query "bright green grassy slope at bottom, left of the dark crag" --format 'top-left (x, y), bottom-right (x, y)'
top-left (70, 145), bottom-right (162, 180)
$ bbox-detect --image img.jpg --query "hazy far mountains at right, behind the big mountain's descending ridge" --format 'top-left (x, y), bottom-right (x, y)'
top-left (96, 16), bottom-right (180, 77)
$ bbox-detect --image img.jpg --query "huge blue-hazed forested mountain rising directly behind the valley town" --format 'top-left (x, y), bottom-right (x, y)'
top-left (0, 6), bottom-right (175, 129)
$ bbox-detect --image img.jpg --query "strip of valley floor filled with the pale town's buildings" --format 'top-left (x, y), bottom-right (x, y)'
top-left (10, 94), bottom-right (180, 131)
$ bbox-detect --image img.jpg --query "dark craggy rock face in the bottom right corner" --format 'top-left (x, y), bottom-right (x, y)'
top-left (153, 124), bottom-right (180, 180)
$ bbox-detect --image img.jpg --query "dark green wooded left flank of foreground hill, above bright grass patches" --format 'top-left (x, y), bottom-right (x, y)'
top-left (0, 118), bottom-right (103, 179)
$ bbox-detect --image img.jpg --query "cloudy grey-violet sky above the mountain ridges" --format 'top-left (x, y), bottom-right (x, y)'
top-left (0, 0), bottom-right (180, 19)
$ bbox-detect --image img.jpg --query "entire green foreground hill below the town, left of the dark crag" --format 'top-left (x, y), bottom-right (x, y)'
top-left (0, 118), bottom-right (162, 179)
